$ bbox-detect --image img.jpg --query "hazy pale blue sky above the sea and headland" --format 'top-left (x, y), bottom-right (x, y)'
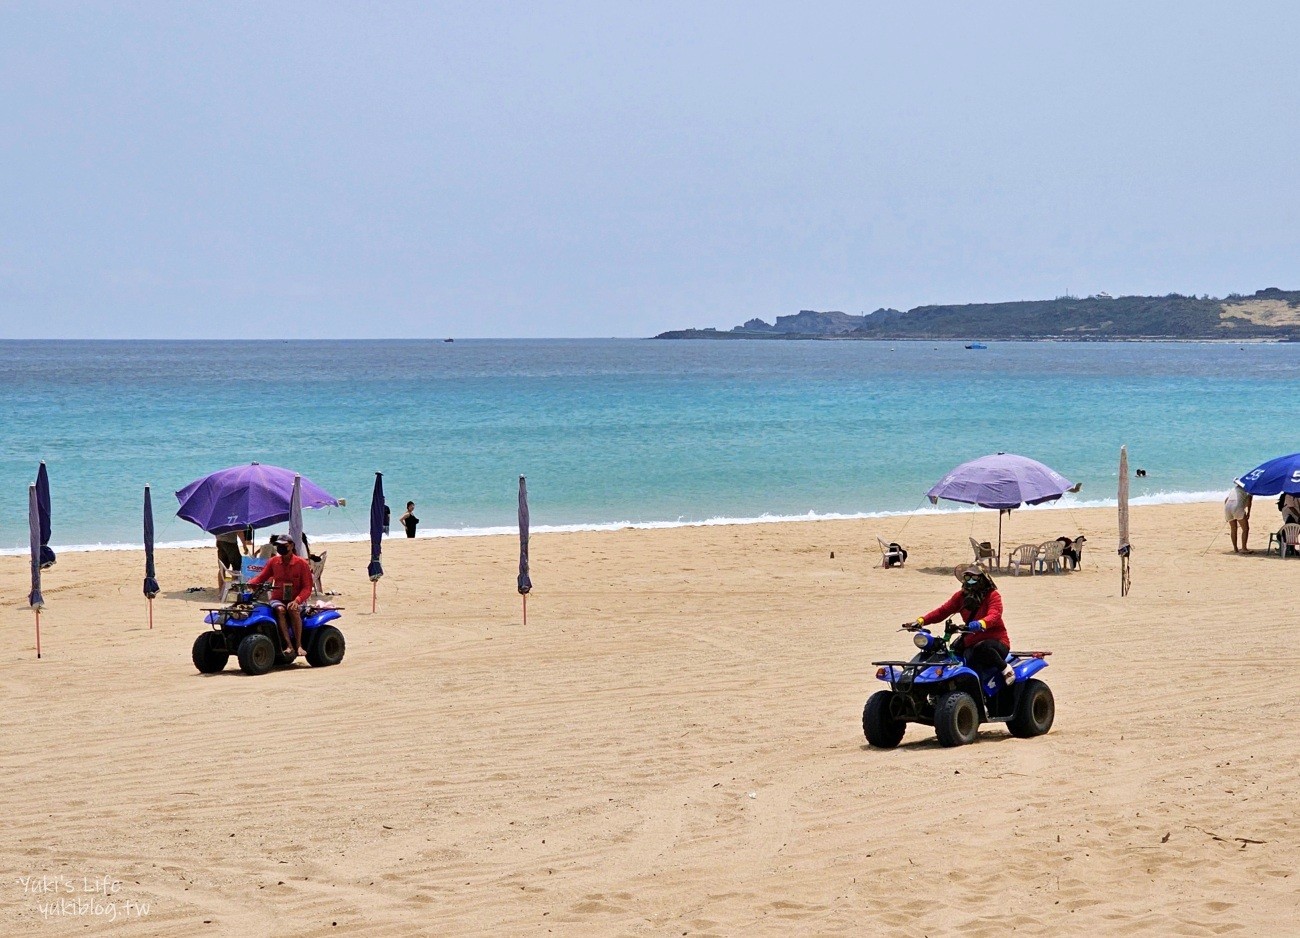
top-left (0, 0), bottom-right (1300, 339)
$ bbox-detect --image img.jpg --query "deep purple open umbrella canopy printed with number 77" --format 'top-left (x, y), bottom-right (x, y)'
top-left (176, 463), bottom-right (338, 534)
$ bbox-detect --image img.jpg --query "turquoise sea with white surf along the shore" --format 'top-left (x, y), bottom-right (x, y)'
top-left (0, 339), bottom-right (1300, 553)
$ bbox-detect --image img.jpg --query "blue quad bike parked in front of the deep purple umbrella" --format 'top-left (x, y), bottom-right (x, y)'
top-left (191, 586), bottom-right (346, 674)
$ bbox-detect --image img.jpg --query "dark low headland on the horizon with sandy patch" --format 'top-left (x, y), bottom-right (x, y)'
top-left (655, 287), bottom-right (1300, 342)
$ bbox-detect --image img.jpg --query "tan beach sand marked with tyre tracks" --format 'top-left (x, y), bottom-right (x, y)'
top-left (0, 503), bottom-right (1300, 935)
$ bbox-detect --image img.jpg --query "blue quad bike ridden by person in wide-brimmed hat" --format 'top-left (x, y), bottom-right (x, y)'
top-left (862, 620), bottom-right (1056, 750)
